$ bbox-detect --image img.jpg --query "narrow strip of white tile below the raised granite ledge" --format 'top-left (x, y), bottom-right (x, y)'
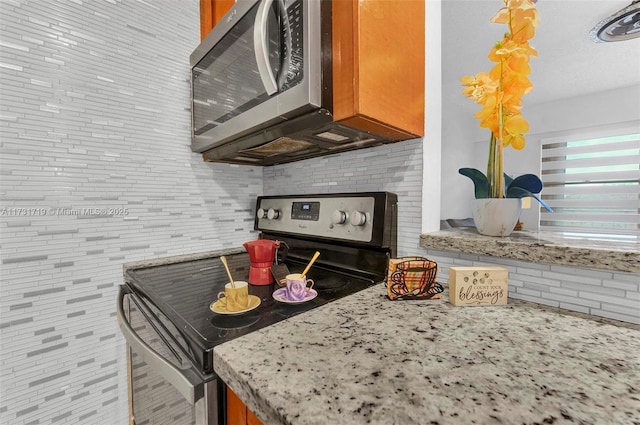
top-left (425, 249), bottom-right (640, 324)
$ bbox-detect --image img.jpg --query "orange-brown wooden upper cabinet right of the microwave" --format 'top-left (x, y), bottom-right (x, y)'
top-left (332, 0), bottom-right (425, 140)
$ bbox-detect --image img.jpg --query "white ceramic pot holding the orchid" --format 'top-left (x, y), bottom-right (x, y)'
top-left (472, 198), bottom-right (522, 236)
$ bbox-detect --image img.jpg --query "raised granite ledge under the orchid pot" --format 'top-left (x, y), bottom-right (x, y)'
top-left (420, 227), bottom-right (640, 273)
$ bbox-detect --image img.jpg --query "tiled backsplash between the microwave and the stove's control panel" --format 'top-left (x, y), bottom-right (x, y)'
top-left (263, 139), bottom-right (422, 256)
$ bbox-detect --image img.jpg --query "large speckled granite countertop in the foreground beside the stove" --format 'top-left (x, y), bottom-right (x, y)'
top-left (214, 285), bottom-right (640, 425)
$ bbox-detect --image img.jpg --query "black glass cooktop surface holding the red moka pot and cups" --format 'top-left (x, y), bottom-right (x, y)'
top-left (127, 253), bottom-right (376, 372)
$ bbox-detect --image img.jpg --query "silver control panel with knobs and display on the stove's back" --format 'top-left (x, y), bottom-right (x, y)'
top-left (255, 195), bottom-right (376, 242)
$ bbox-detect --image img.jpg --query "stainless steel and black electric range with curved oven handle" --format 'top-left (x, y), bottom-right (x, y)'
top-left (117, 192), bottom-right (397, 425)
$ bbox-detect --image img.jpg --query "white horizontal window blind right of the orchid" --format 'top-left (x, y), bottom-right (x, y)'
top-left (540, 124), bottom-right (640, 241)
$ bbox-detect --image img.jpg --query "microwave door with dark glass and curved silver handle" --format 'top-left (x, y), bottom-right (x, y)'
top-left (192, 0), bottom-right (304, 136)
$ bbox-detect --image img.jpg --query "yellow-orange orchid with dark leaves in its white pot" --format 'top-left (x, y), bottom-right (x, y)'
top-left (458, 0), bottom-right (551, 236)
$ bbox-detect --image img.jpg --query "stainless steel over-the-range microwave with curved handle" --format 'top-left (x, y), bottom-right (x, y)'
top-left (191, 0), bottom-right (330, 163)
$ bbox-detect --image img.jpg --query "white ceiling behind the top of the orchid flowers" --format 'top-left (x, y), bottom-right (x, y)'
top-left (442, 0), bottom-right (640, 104)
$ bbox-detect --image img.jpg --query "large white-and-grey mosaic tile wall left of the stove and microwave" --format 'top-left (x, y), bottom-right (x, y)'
top-left (0, 0), bottom-right (263, 425)
